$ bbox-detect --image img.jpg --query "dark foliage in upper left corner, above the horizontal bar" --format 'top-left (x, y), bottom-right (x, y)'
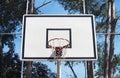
top-left (0, 0), bottom-right (26, 33)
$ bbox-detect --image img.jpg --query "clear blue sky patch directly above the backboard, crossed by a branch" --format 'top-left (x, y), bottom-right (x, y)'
top-left (35, 0), bottom-right (68, 14)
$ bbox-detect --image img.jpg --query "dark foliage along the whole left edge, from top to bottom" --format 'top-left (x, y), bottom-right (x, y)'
top-left (0, 0), bottom-right (26, 78)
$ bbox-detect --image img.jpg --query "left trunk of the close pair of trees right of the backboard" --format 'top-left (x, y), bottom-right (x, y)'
top-left (104, 3), bottom-right (111, 78)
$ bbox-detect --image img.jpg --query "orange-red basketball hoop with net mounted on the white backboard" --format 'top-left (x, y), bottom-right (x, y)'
top-left (48, 38), bottom-right (69, 58)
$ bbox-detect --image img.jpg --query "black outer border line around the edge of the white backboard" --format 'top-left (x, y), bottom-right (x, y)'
top-left (21, 14), bottom-right (97, 61)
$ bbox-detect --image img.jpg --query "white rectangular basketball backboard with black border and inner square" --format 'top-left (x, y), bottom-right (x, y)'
top-left (21, 15), bottom-right (97, 61)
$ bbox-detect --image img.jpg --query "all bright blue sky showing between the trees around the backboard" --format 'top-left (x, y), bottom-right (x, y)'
top-left (12, 0), bottom-right (120, 78)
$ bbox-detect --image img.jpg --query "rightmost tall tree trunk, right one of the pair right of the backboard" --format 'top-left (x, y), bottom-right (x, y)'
top-left (108, 0), bottom-right (117, 78)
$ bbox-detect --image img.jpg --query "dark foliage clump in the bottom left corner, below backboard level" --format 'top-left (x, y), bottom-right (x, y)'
top-left (4, 53), bottom-right (21, 78)
